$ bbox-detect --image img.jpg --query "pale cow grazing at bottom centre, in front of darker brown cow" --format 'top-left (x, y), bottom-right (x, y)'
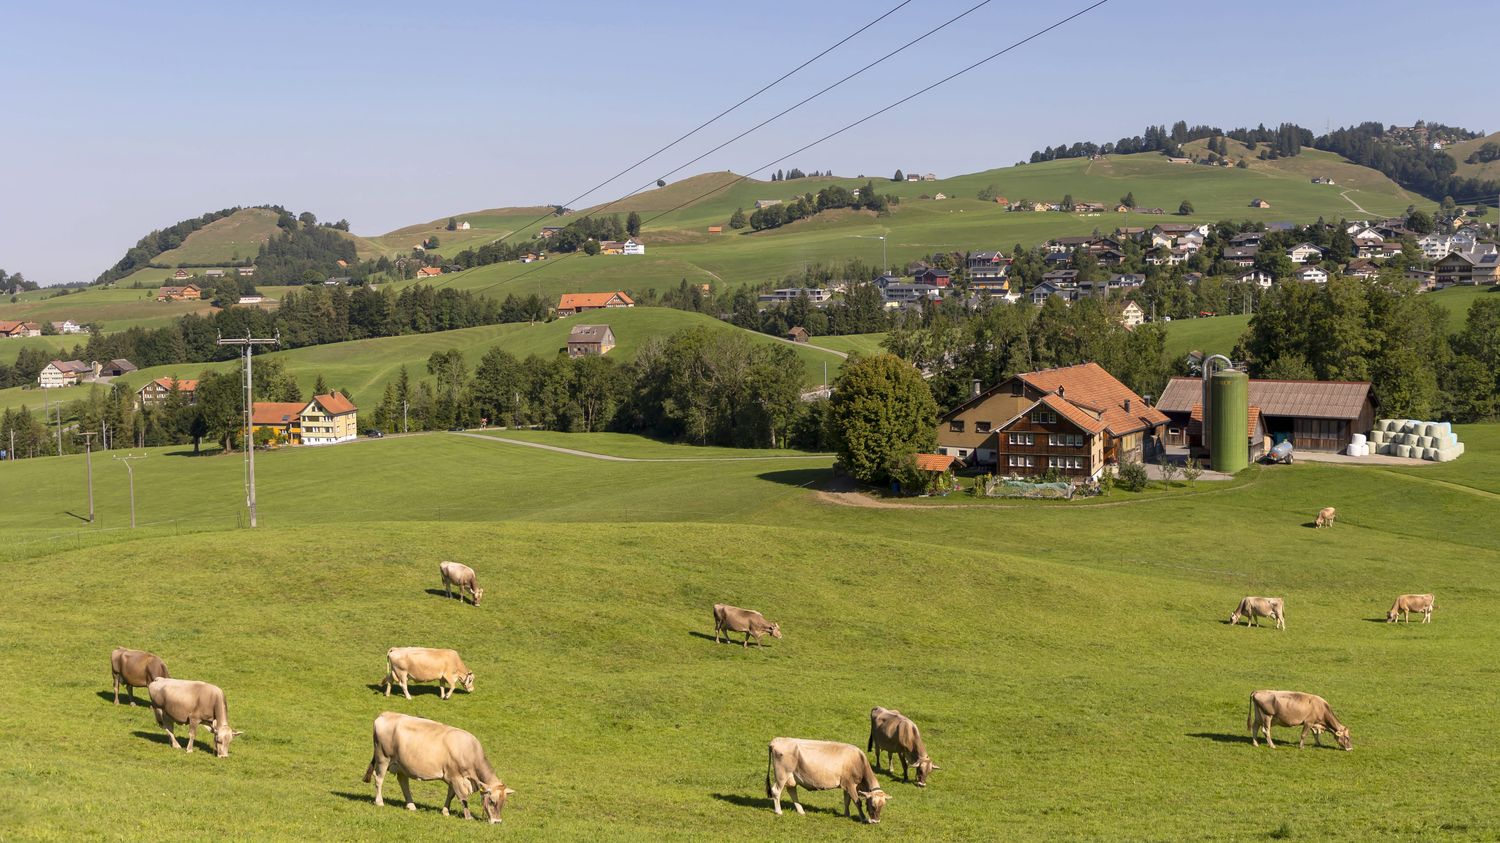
top-left (765, 738), bottom-right (890, 824)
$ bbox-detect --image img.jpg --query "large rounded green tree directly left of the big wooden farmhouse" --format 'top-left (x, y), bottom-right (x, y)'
top-left (828, 354), bottom-right (938, 483)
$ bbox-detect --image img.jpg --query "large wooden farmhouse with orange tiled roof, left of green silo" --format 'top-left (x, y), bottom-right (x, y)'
top-left (938, 363), bottom-right (1167, 482)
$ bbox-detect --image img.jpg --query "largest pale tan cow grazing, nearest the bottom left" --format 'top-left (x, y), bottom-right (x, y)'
top-left (365, 711), bottom-right (515, 824)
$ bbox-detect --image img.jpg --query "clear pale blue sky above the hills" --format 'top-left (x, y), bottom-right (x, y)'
top-left (0, 0), bottom-right (1500, 284)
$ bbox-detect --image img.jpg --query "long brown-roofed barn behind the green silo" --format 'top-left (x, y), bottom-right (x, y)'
top-left (1157, 378), bottom-right (1376, 453)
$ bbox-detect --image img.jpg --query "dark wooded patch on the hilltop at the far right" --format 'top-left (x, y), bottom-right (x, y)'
top-left (1313, 123), bottom-right (1500, 204)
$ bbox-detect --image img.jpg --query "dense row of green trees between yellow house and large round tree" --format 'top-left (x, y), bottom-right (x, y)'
top-left (371, 329), bottom-right (822, 447)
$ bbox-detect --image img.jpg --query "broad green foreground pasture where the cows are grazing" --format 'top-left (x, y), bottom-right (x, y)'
top-left (0, 426), bottom-right (1500, 842)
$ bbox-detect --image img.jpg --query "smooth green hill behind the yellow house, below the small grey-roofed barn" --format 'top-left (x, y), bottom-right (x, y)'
top-left (0, 308), bottom-right (843, 410)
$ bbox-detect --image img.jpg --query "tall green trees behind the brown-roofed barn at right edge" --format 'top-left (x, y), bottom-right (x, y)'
top-left (1235, 278), bottom-right (1500, 422)
